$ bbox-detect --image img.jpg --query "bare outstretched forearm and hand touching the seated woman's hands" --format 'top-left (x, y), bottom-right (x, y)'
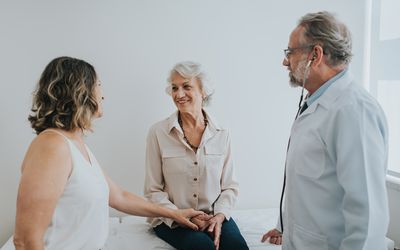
top-left (104, 175), bottom-right (203, 230)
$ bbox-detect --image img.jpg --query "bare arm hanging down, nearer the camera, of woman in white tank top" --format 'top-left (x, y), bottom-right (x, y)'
top-left (14, 133), bottom-right (72, 250)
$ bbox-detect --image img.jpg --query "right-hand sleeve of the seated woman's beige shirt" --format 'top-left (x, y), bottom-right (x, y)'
top-left (214, 133), bottom-right (239, 220)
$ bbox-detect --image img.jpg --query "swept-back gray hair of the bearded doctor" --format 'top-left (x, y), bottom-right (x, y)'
top-left (299, 11), bottom-right (353, 67)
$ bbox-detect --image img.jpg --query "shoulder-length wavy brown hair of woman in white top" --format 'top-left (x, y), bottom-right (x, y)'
top-left (28, 57), bottom-right (98, 134)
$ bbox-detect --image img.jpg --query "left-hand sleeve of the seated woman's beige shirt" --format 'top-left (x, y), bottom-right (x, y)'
top-left (144, 127), bottom-right (177, 227)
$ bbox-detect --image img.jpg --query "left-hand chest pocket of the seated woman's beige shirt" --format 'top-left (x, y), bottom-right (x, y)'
top-left (162, 147), bottom-right (187, 175)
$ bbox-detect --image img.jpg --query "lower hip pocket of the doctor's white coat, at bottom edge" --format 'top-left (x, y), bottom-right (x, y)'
top-left (293, 224), bottom-right (328, 250)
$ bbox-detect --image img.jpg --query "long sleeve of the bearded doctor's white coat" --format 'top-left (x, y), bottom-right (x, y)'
top-left (334, 103), bottom-right (388, 250)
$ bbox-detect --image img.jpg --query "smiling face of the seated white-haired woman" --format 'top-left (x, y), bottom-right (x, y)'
top-left (171, 73), bottom-right (203, 113)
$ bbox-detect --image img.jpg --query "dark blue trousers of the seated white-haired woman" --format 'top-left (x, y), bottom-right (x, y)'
top-left (154, 218), bottom-right (249, 250)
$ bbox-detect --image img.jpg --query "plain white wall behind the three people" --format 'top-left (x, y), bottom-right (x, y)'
top-left (0, 0), bottom-right (365, 245)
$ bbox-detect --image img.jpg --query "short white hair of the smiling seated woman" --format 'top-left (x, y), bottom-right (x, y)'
top-left (166, 61), bottom-right (214, 106)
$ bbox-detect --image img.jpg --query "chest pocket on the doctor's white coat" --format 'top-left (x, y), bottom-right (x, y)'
top-left (293, 134), bottom-right (326, 179)
